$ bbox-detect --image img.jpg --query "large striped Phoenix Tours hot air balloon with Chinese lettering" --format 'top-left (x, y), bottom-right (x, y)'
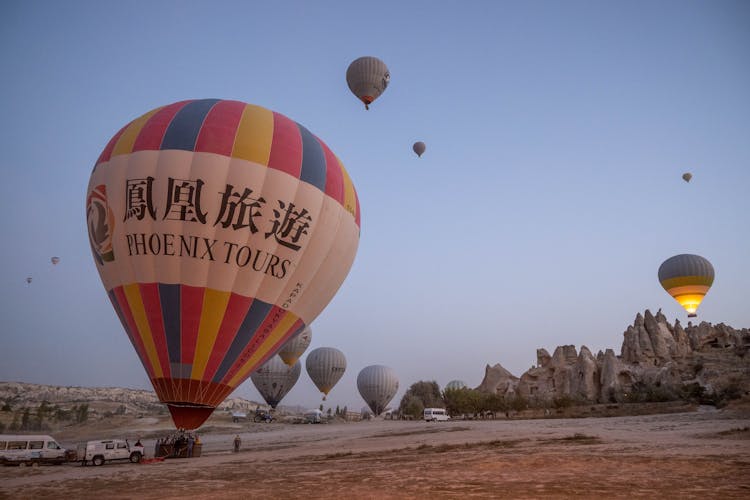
top-left (86, 99), bottom-right (360, 429)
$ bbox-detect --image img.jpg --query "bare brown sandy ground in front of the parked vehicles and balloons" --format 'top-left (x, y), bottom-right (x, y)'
top-left (0, 405), bottom-right (750, 499)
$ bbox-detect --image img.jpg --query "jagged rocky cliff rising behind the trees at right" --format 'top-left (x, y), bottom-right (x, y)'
top-left (477, 310), bottom-right (750, 403)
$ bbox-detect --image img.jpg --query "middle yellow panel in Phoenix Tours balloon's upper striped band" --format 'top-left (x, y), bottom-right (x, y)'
top-left (232, 104), bottom-right (273, 166)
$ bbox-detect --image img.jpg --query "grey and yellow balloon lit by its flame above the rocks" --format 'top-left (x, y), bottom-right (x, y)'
top-left (659, 254), bottom-right (714, 318)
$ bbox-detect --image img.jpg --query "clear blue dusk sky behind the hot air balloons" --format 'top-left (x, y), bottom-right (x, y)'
top-left (0, 0), bottom-right (750, 409)
